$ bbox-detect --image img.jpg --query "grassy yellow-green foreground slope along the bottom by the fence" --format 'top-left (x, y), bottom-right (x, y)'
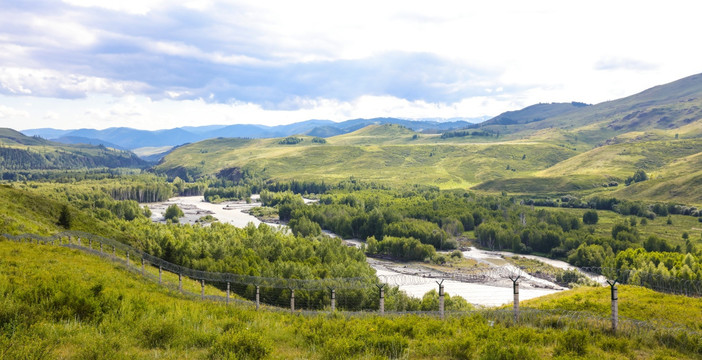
top-left (0, 241), bottom-right (702, 359)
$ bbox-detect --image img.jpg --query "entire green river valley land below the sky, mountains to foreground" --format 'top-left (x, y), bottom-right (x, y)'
top-left (0, 71), bottom-right (702, 358)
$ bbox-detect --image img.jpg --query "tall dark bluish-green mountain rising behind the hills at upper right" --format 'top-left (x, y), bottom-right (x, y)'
top-left (477, 74), bottom-right (702, 146)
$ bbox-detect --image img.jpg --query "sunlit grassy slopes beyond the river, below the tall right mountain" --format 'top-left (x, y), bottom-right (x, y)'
top-left (155, 116), bottom-right (702, 204)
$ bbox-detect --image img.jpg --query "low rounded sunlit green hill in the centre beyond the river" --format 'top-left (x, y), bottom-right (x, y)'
top-left (155, 125), bottom-right (576, 188)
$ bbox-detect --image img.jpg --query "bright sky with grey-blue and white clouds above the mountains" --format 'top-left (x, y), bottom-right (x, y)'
top-left (0, 0), bottom-right (702, 130)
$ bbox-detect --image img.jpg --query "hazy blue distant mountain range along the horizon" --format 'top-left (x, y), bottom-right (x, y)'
top-left (22, 118), bottom-right (484, 150)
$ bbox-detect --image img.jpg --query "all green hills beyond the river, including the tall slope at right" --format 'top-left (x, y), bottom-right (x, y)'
top-left (155, 74), bottom-right (702, 204)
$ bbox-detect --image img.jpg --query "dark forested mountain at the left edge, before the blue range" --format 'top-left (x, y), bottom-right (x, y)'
top-left (0, 128), bottom-right (148, 172)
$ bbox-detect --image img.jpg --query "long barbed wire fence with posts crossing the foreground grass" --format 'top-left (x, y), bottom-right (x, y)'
top-left (0, 231), bottom-right (702, 342)
